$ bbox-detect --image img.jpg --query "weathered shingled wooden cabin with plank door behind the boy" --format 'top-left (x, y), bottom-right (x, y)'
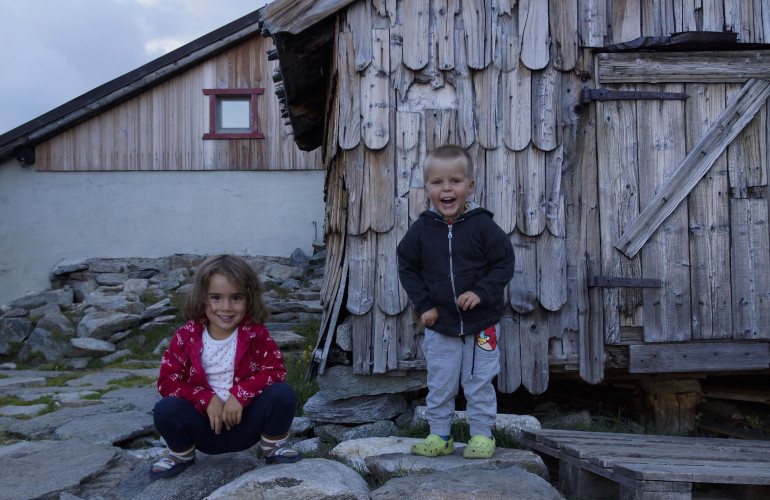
top-left (262, 0), bottom-right (770, 430)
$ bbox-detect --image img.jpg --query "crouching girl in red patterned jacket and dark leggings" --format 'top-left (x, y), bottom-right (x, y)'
top-left (150, 255), bottom-right (302, 478)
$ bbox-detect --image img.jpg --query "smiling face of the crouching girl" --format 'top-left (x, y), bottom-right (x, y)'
top-left (206, 274), bottom-right (247, 340)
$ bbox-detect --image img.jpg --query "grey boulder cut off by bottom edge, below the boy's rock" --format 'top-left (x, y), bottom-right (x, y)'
top-left (371, 461), bottom-right (564, 500)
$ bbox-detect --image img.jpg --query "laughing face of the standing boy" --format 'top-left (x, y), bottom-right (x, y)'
top-left (425, 158), bottom-right (474, 219)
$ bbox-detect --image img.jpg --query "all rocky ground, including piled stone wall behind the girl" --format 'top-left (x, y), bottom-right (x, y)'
top-left (0, 252), bottom-right (561, 500)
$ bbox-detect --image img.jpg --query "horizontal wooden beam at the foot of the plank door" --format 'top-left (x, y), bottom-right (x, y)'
top-left (628, 342), bottom-right (770, 373)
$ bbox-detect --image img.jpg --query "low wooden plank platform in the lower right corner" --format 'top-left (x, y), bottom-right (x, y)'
top-left (521, 429), bottom-right (770, 500)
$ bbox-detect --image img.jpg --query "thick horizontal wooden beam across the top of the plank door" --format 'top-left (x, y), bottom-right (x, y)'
top-left (597, 50), bottom-right (770, 85)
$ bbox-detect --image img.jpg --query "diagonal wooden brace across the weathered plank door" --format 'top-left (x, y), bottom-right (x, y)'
top-left (615, 79), bottom-right (770, 258)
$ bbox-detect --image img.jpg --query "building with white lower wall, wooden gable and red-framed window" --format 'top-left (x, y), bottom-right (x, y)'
top-left (0, 11), bottom-right (324, 306)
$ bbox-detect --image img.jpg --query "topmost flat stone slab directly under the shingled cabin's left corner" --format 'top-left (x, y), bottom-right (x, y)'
top-left (317, 365), bottom-right (428, 399)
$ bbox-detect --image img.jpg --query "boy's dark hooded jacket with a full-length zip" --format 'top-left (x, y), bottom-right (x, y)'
top-left (397, 206), bottom-right (514, 336)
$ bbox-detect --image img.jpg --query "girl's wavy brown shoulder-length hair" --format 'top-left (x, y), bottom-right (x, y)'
top-left (182, 255), bottom-right (270, 324)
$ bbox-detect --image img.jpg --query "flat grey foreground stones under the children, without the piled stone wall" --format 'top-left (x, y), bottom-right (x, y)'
top-left (0, 367), bottom-right (561, 499)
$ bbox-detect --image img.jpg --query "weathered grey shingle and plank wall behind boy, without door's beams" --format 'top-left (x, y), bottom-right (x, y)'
top-left (308, 0), bottom-right (770, 393)
